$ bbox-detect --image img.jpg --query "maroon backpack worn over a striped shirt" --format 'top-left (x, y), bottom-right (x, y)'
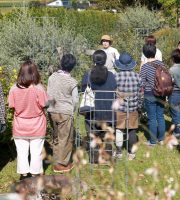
top-left (152, 63), bottom-right (173, 97)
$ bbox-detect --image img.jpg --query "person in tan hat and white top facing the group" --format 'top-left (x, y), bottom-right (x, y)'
top-left (101, 35), bottom-right (120, 74)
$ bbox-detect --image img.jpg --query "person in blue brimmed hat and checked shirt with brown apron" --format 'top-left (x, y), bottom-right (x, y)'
top-left (112, 52), bottom-right (143, 160)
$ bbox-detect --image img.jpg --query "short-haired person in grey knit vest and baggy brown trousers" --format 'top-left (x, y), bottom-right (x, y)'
top-left (47, 54), bottom-right (78, 173)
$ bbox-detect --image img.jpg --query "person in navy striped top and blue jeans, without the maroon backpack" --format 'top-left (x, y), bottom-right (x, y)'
top-left (140, 44), bottom-right (166, 146)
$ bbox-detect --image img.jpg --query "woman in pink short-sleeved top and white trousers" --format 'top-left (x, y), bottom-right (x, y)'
top-left (8, 60), bottom-right (48, 180)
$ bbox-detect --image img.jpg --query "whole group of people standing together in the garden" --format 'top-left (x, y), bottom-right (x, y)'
top-left (0, 35), bottom-right (180, 179)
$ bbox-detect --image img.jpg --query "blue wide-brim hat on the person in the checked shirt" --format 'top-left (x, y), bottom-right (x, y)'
top-left (115, 52), bottom-right (137, 71)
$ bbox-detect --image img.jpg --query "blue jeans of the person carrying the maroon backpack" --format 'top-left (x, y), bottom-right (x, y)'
top-left (144, 94), bottom-right (165, 144)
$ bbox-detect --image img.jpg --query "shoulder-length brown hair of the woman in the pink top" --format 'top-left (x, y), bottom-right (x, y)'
top-left (17, 60), bottom-right (40, 88)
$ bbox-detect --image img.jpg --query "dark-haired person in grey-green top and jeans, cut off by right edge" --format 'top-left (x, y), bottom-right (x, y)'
top-left (169, 48), bottom-right (180, 138)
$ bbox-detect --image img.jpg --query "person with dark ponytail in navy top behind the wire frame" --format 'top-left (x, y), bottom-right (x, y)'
top-left (82, 50), bottom-right (116, 163)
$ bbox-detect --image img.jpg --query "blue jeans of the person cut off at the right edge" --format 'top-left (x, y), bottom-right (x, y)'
top-left (169, 91), bottom-right (180, 135)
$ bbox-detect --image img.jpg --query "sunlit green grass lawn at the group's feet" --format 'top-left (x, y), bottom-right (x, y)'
top-left (0, 114), bottom-right (180, 200)
